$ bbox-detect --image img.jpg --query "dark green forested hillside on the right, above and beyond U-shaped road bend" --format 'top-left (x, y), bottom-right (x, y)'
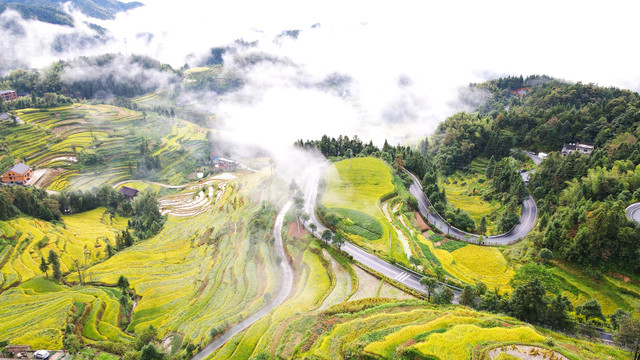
top-left (432, 76), bottom-right (640, 274)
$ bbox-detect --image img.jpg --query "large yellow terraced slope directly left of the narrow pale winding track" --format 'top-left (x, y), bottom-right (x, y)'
top-left (67, 174), bottom-right (288, 345)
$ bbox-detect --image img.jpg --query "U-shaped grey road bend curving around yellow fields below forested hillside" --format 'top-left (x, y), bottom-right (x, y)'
top-left (409, 173), bottom-right (538, 245)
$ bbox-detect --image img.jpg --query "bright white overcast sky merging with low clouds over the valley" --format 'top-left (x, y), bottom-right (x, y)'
top-left (0, 0), bottom-right (640, 148)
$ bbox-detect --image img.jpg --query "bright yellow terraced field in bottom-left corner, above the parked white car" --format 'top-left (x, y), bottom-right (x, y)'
top-left (0, 277), bottom-right (132, 349)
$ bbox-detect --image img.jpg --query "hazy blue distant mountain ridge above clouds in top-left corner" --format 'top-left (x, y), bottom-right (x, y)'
top-left (0, 0), bottom-right (143, 26)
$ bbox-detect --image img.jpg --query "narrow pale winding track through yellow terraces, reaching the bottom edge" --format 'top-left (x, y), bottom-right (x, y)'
top-left (192, 200), bottom-right (293, 360)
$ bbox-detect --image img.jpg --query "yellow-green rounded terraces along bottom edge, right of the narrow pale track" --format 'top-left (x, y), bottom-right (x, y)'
top-left (238, 299), bottom-right (628, 360)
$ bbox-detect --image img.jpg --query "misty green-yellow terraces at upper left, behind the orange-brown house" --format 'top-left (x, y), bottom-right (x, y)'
top-left (5, 104), bottom-right (208, 190)
